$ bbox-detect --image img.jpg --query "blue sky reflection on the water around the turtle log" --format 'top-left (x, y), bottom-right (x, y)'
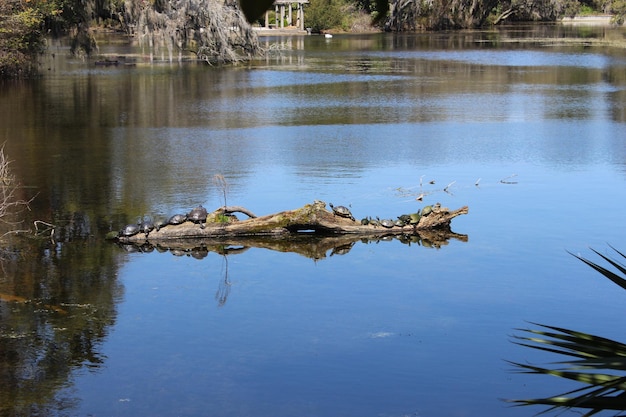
top-left (52, 31), bottom-right (626, 417)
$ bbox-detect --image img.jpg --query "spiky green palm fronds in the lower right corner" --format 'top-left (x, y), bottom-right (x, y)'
top-left (507, 246), bottom-right (626, 416)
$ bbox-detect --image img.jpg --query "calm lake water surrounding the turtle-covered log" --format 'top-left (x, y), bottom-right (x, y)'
top-left (0, 25), bottom-right (626, 417)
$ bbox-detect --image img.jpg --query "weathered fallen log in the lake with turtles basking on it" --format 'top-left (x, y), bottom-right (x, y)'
top-left (116, 201), bottom-right (469, 242)
